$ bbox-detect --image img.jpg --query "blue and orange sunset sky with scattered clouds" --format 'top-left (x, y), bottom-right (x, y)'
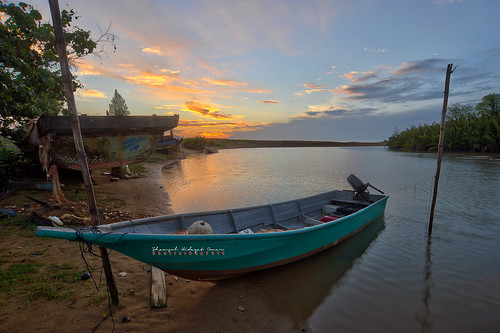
top-left (26, 0), bottom-right (500, 141)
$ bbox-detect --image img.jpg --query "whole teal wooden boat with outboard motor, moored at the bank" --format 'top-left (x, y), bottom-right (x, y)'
top-left (36, 175), bottom-right (388, 280)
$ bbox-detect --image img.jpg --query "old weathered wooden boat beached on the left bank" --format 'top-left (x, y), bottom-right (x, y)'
top-left (18, 115), bottom-right (179, 170)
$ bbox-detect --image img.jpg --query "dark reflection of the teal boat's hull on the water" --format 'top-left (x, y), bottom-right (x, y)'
top-left (214, 218), bottom-right (385, 330)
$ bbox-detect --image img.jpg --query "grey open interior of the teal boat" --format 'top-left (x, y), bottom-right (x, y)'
top-left (103, 191), bottom-right (385, 234)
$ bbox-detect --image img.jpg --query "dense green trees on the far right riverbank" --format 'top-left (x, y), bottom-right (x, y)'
top-left (388, 94), bottom-right (500, 153)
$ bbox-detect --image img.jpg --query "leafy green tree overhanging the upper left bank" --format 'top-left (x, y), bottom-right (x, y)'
top-left (0, 0), bottom-right (115, 139)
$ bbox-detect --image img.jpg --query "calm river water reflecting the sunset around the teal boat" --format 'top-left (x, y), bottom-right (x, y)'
top-left (164, 147), bottom-right (500, 332)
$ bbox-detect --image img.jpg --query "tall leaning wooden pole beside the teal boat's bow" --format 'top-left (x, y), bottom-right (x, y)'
top-left (49, 0), bottom-right (119, 305)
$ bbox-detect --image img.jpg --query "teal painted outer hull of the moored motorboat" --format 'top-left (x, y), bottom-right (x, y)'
top-left (37, 189), bottom-right (388, 280)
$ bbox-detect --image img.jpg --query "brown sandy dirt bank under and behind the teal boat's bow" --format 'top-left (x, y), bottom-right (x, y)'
top-left (0, 152), bottom-right (302, 332)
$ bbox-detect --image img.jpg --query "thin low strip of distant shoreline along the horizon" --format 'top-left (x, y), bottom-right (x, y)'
top-left (210, 139), bottom-right (387, 149)
